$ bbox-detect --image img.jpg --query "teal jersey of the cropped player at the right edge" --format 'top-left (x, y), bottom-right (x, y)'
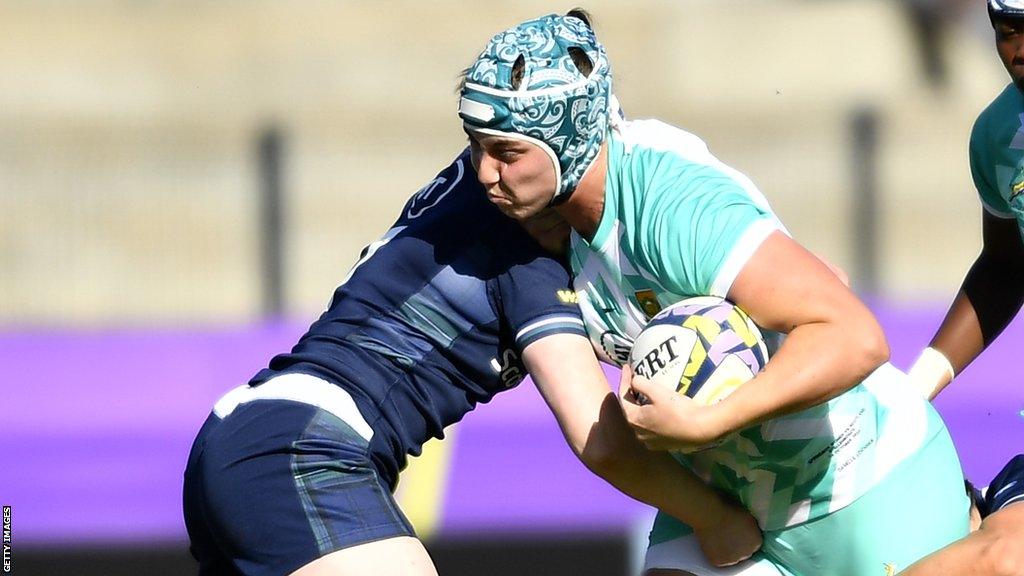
top-left (971, 84), bottom-right (1024, 230)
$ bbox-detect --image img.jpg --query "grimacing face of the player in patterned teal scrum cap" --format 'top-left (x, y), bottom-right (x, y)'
top-left (469, 133), bottom-right (555, 220)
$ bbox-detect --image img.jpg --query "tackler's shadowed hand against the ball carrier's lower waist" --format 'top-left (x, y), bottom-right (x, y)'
top-left (693, 487), bottom-right (762, 567)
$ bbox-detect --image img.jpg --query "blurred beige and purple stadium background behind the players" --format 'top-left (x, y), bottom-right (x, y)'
top-left (6, 0), bottom-right (1024, 575)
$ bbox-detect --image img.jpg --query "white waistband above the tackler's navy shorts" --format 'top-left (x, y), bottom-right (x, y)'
top-left (213, 373), bottom-right (374, 442)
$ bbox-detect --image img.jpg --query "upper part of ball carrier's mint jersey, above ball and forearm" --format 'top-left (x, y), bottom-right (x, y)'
top-left (570, 120), bottom-right (785, 366)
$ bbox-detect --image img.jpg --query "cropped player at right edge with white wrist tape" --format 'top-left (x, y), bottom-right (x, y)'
top-left (910, 0), bottom-right (1024, 398)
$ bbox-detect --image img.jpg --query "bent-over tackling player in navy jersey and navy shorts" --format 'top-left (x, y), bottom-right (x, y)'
top-left (184, 148), bottom-right (760, 576)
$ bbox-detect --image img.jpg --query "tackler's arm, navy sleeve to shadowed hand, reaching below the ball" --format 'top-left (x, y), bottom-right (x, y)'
top-left (499, 210), bottom-right (761, 566)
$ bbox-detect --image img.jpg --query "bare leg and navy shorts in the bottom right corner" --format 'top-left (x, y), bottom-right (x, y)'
top-left (900, 454), bottom-right (1024, 576)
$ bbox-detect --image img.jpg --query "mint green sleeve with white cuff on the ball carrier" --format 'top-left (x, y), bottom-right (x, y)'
top-left (645, 168), bottom-right (785, 297)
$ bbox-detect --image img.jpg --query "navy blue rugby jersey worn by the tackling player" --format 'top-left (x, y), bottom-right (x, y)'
top-left (250, 152), bottom-right (586, 483)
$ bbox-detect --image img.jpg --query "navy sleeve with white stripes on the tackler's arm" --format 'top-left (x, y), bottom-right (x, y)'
top-left (497, 255), bottom-right (587, 352)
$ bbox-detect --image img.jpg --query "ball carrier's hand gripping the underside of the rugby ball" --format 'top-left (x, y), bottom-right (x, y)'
top-left (618, 365), bottom-right (723, 452)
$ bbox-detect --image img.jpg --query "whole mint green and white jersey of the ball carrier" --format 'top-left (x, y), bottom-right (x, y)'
top-left (570, 120), bottom-right (936, 530)
